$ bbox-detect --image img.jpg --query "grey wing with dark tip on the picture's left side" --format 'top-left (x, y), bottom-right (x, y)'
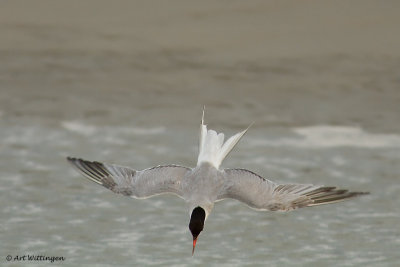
top-left (67, 157), bottom-right (190, 198)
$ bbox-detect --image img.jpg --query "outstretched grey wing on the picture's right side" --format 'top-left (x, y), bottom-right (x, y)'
top-left (218, 169), bottom-right (367, 211)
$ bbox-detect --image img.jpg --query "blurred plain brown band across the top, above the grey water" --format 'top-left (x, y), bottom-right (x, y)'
top-left (0, 0), bottom-right (400, 132)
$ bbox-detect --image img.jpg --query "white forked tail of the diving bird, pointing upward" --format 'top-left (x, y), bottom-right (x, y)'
top-left (197, 108), bottom-right (250, 169)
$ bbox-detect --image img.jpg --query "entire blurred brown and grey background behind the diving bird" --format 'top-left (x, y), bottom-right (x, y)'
top-left (0, 0), bottom-right (400, 266)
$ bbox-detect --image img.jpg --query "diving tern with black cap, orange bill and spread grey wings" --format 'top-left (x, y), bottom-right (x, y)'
top-left (67, 108), bottom-right (369, 256)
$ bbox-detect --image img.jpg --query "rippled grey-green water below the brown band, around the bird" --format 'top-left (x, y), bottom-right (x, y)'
top-left (1, 121), bottom-right (400, 266)
